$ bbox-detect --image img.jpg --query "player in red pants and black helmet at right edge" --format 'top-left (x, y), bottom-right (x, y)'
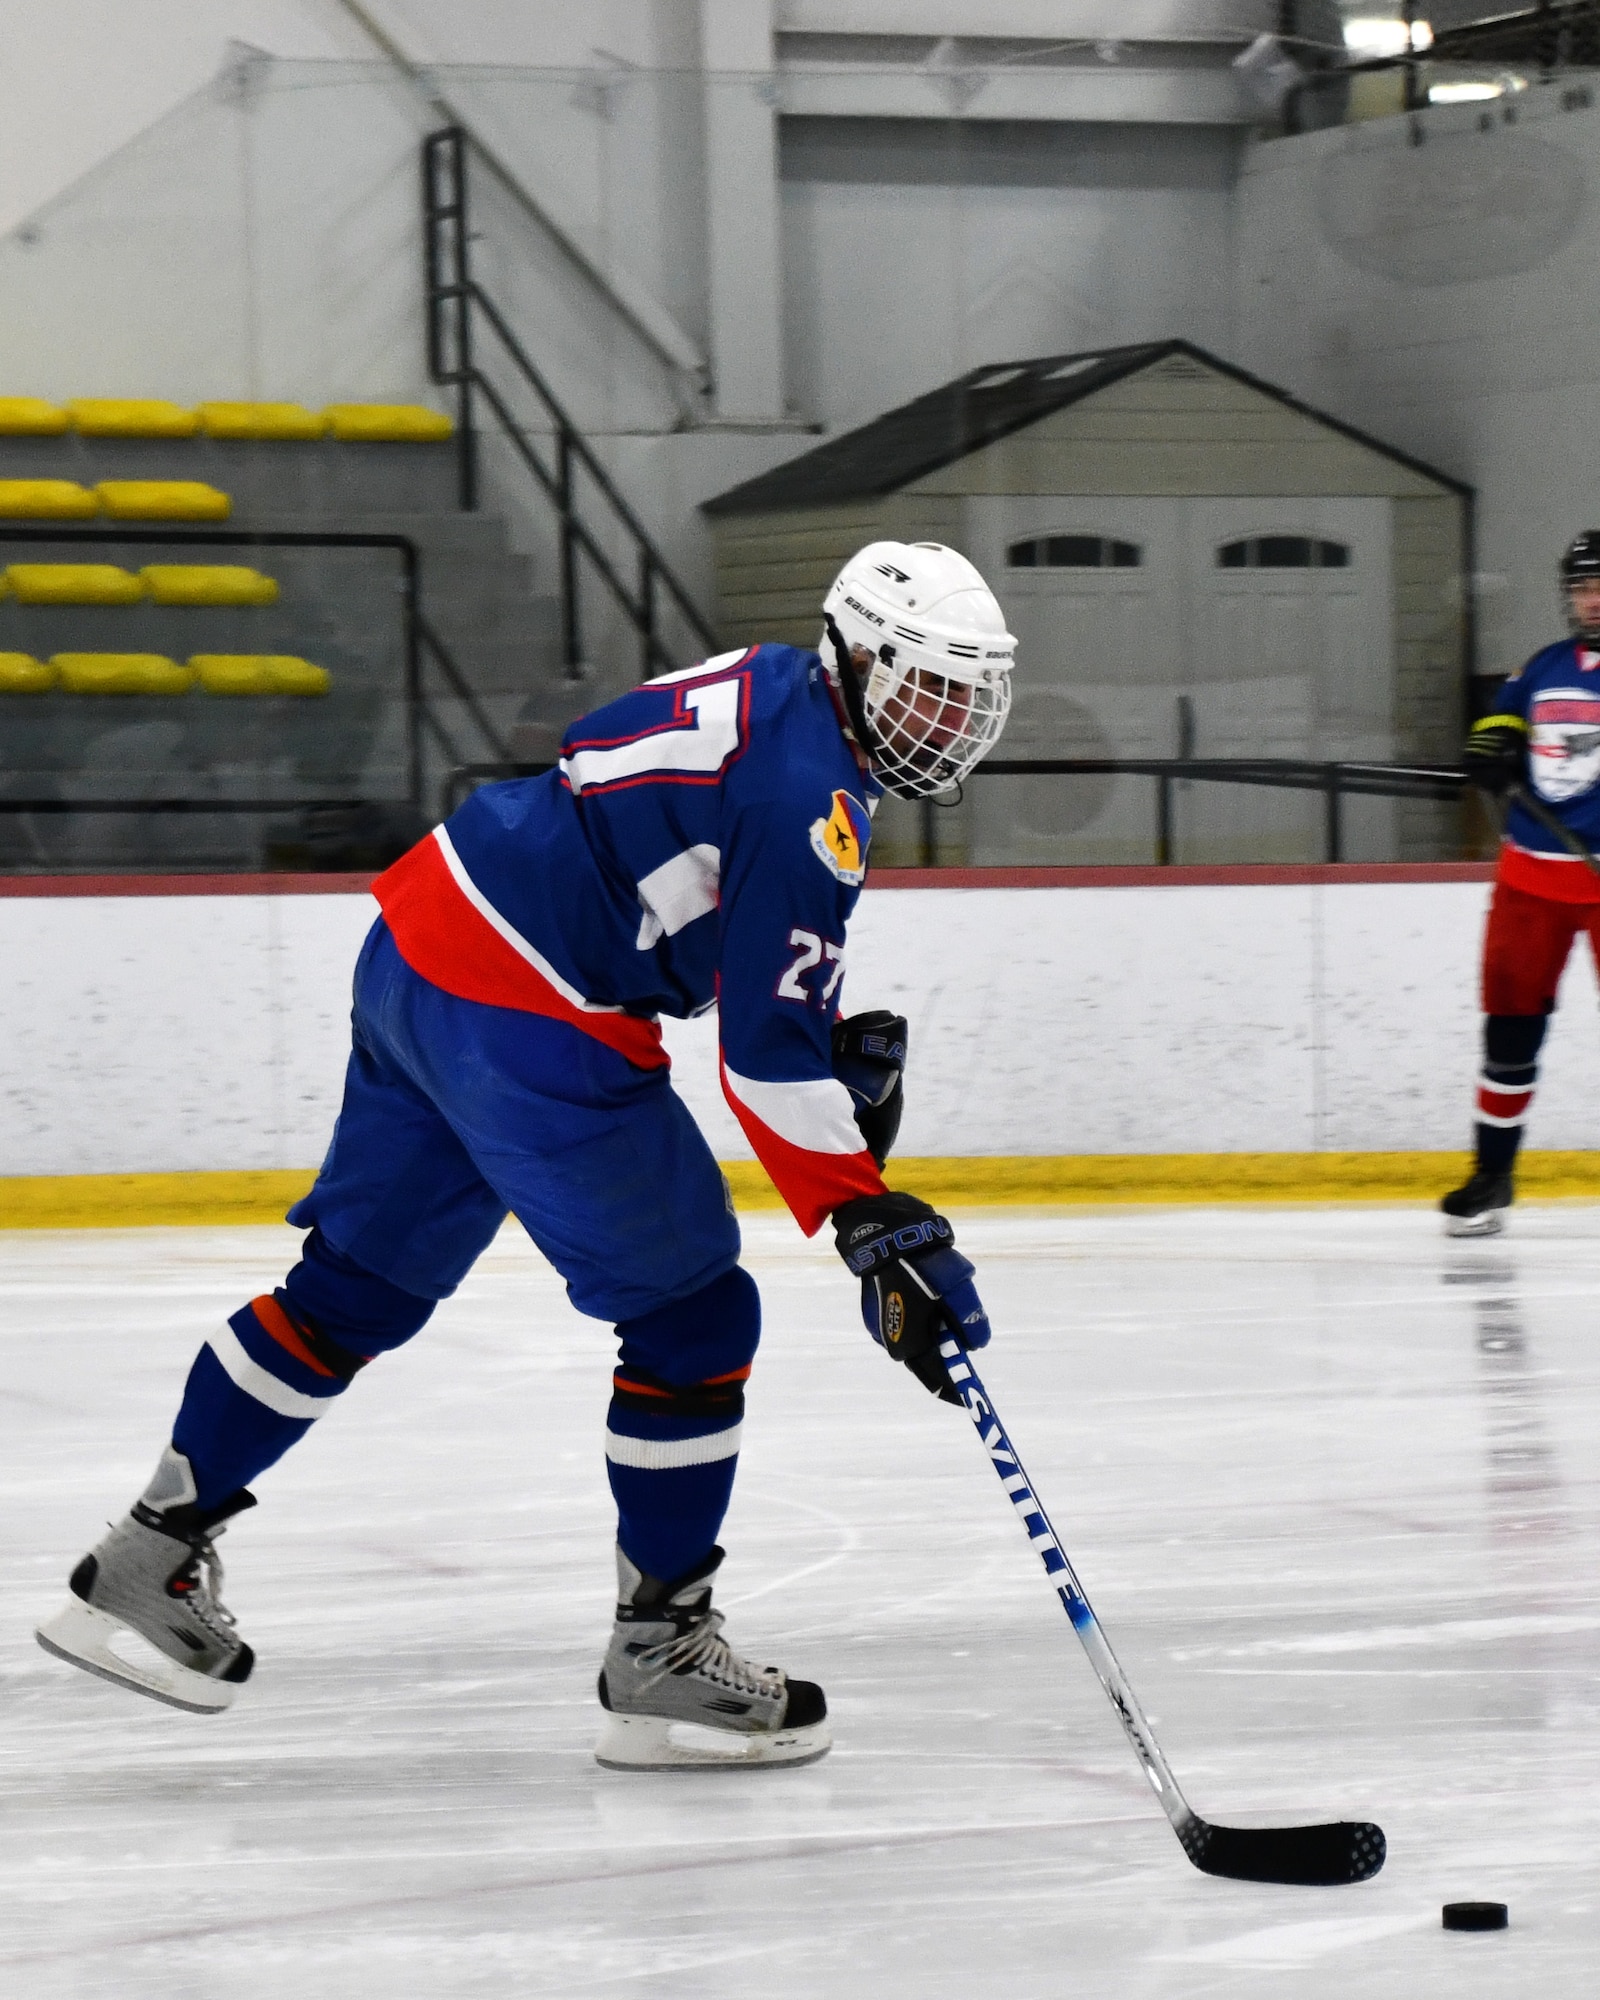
top-left (1440, 528), bottom-right (1600, 1236)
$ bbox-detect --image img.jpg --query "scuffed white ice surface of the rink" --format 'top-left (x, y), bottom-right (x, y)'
top-left (0, 1204), bottom-right (1600, 2000)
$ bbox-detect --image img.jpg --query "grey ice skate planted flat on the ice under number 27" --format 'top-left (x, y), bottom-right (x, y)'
top-left (594, 1548), bottom-right (834, 1770)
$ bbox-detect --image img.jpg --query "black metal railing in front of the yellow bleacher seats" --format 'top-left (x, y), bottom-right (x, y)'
top-left (0, 522), bottom-right (510, 814)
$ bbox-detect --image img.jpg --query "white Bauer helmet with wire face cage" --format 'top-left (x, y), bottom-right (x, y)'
top-left (822, 542), bottom-right (1016, 798)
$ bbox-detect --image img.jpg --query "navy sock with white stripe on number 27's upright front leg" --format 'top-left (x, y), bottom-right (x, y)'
top-left (606, 1268), bottom-right (760, 1578)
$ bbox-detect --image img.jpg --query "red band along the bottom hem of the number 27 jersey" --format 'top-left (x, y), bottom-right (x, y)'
top-left (372, 834), bottom-right (670, 1070)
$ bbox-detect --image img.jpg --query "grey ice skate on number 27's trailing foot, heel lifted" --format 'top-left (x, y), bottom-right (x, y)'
top-left (36, 1448), bottom-right (256, 1716)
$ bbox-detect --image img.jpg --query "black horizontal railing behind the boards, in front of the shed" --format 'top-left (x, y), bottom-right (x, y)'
top-left (440, 756), bottom-right (1466, 866)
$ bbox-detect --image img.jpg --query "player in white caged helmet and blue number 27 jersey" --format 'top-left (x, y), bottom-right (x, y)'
top-left (40, 542), bottom-right (1014, 1768)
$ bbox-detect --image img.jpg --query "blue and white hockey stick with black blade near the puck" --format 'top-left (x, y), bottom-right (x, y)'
top-left (938, 1340), bottom-right (1388, 1888)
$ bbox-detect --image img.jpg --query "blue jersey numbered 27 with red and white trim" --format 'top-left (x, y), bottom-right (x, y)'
top-left (374, 646), bottom-right (884, 1234)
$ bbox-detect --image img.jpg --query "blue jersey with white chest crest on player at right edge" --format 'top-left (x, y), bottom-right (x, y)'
top-left (1480, 638), bottom-right (1600, 900)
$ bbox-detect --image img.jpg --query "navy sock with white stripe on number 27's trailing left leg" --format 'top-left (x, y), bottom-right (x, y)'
top-left (172, 1230), bottom-right (434, 1508)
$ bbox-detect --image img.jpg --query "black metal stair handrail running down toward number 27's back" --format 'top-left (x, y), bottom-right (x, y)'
top-left (422, 126), bottom-right (718, 680)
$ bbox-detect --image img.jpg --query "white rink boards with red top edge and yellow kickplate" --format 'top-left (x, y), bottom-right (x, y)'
top-left (0, 868), bottom-right (1596, 1220)
